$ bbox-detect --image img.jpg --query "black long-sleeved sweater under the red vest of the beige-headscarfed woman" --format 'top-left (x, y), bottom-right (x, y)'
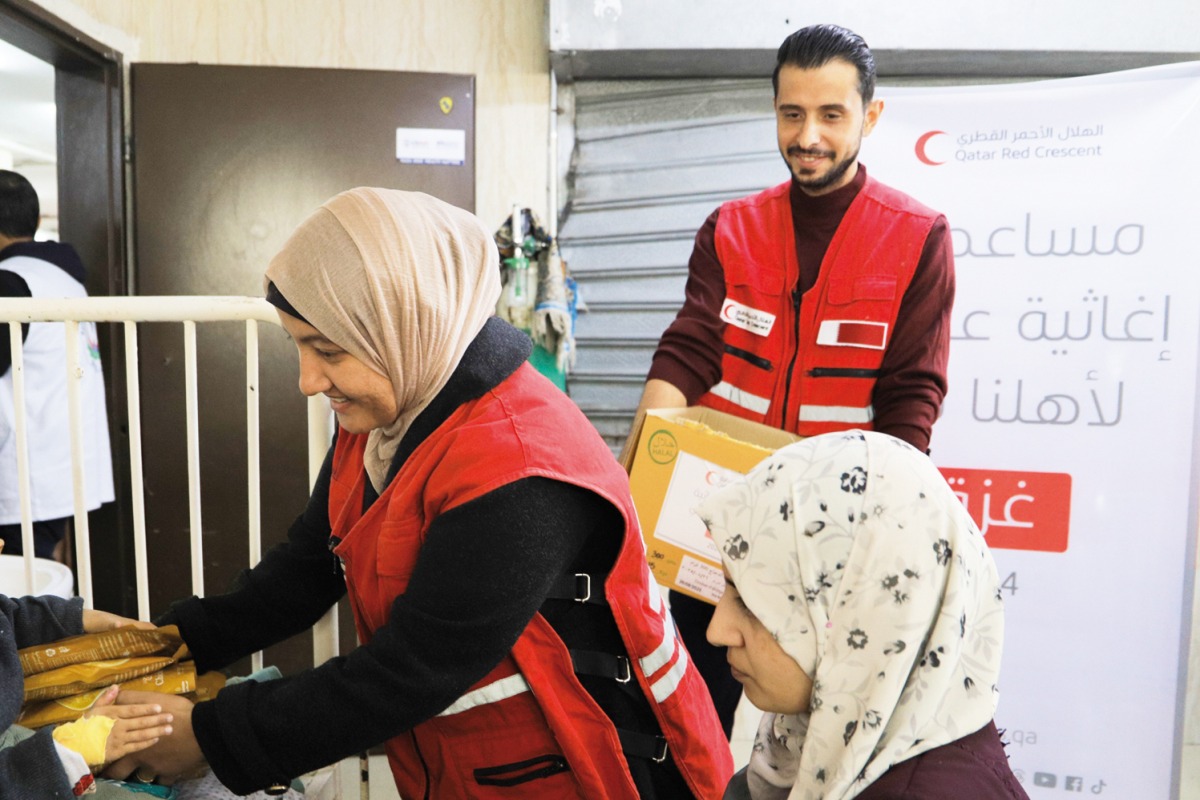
top-left (162, 319), bottom-right (688, 798)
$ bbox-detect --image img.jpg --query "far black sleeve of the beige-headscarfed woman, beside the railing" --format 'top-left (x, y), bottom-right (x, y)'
top-left (155, 447), bottom-right (346, 672)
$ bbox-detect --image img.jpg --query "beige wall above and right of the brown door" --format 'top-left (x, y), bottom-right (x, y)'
top-left (41, 0), bottom-right (550, 230)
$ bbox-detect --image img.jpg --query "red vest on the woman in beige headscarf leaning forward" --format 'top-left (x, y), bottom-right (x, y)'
top-left (329, 363), bottom-right (733, 800)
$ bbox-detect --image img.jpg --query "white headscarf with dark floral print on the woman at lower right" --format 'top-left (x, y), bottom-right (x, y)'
top-left (700, 431), bottom-right (1004, 800)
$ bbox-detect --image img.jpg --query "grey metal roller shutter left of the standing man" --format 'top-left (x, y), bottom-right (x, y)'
top-left (559, 79), bottom-right (772, 449)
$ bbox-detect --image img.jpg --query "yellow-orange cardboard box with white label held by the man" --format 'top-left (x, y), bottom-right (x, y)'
top-left (629, 407), bottom-right (800, 603)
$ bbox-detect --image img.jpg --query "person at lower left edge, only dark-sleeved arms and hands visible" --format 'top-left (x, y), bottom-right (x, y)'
top-left (0, 587), bottom-right (172, 800)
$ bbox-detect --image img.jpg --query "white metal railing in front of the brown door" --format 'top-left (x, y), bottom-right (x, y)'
top-left (0, 296), bottom-right (337, 669)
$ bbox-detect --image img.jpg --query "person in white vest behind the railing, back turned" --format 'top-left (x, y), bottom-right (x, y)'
top-left (0, 169), bottom-right (113, 561)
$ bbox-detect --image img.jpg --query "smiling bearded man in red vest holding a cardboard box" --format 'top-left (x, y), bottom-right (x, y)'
top-left (626, 25), bottom-right (954, 735)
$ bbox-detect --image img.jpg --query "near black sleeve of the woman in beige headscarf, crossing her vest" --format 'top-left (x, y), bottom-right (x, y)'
top-left (192, 477), bottom-right (595, 793)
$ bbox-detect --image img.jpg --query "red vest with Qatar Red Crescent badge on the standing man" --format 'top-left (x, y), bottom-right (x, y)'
top-left (700, 176), bottom-right (940, 437)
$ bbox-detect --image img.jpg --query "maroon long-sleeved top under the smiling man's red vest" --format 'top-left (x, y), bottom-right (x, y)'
top-left (648, 164), bottom-right (954, 451)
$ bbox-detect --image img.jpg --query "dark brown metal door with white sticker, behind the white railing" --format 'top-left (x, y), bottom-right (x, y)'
top-left (130, 64), bottom-right (475, 663)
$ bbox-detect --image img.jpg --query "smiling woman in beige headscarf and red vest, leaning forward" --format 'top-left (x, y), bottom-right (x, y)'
top-left (110, 188), bottom-right (732, 800)
